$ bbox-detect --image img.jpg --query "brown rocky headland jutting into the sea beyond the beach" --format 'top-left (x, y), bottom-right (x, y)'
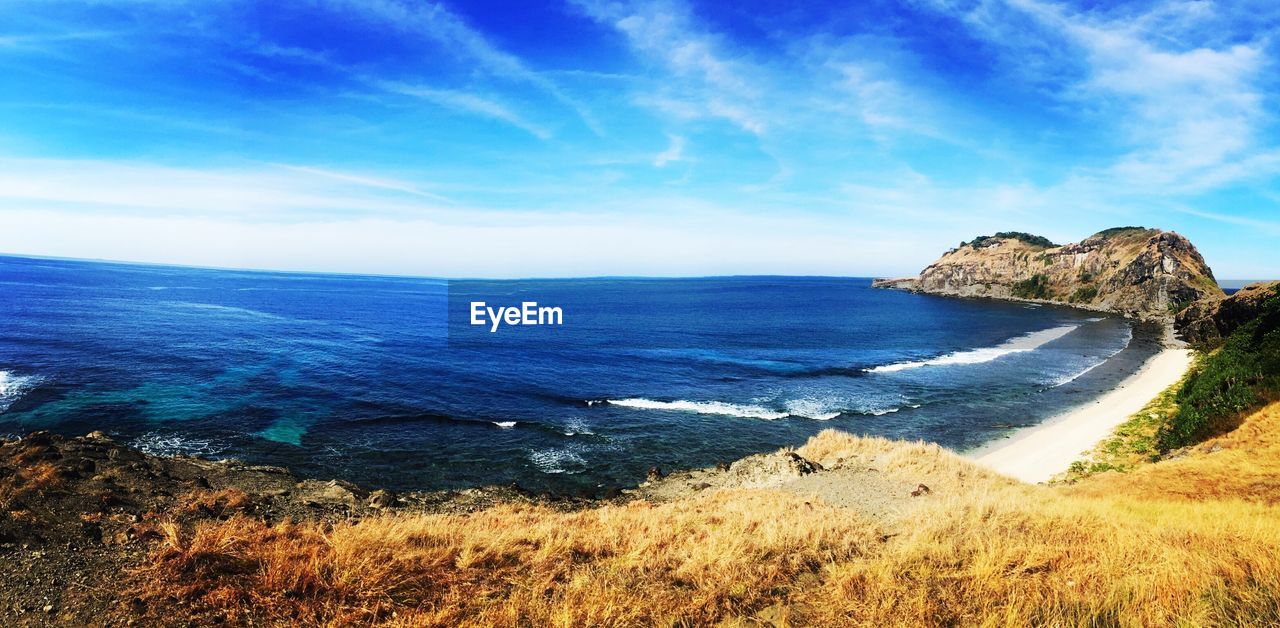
top-left (873, 228), bottom-right (1222, 321)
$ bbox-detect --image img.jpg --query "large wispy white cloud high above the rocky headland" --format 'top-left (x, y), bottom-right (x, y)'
top-left (933, 0), bottom-right (1268, 189)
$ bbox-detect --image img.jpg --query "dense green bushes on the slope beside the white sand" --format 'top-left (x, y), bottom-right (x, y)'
top-left (1158, 297), bottom-right (1280, 451)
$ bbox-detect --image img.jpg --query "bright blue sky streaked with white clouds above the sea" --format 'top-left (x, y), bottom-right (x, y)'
top-left (0, 0), bottom-right (1280, 279)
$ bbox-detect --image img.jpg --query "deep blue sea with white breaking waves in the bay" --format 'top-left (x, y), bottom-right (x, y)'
top-left (0, 257), bottom-right (1158, 492)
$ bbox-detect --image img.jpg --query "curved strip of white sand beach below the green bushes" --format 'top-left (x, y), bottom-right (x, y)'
top-left (969, 349), bottom-right (1192, 483)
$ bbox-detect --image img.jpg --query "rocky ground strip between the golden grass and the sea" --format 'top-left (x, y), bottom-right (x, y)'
top-left (0, 422), bottom-right (963, 625)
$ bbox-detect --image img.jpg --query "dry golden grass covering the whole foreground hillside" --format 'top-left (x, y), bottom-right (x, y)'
top-left (138, 405), bottom-right (1280, 625)
